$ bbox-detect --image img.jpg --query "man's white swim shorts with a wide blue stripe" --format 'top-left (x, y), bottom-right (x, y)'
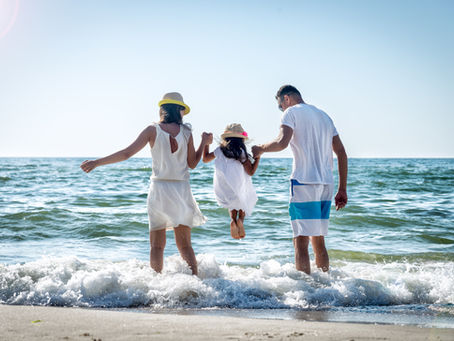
top-left (289, 179), bottom-right (334, 237)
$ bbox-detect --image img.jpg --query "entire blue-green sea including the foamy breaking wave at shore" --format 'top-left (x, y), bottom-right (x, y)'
top-left (0, 158), bottom-right (454, 328)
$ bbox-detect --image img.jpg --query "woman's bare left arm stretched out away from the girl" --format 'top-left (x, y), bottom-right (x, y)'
top-left (80, 126), bottom-right (156, 173)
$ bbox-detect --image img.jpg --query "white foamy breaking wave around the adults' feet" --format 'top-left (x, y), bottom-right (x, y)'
top-left (0, 254), bottom-right (454, 309)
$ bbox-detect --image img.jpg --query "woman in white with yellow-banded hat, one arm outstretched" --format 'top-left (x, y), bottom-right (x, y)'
top-left (81, 92), bottom-right (210, 275)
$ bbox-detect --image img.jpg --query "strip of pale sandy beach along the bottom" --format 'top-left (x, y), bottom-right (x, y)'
top-left (0, 305), bottom-right (454, 341)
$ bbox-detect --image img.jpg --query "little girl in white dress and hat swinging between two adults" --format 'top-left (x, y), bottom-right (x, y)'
top-left (203, 123), bottom-right (260, 239)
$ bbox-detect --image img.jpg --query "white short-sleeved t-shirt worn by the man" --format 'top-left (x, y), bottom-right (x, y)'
top-left (281, 103), bottom-right (338, 184)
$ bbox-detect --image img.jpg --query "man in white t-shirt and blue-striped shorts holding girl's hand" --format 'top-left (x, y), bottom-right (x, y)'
top-left (252, 85), bottom-right (348, 274)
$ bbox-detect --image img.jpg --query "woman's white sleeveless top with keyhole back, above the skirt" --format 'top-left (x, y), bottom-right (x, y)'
top-left (151, 123), bottom-right (191, 181)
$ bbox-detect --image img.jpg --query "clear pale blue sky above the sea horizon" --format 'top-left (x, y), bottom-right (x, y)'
top-left (0, 0), bottom-right (454, 158)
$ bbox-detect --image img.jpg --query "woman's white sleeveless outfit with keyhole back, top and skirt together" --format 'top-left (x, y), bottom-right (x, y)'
top-left (147, 124), bottom-right (206, 231)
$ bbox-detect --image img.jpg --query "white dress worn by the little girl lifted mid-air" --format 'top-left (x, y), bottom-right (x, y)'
top-left (213, 147), bottom-right (257, 216)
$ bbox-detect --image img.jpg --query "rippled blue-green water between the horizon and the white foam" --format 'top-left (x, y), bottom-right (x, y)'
top-left (0, 159), bottom-right (454, 264)
